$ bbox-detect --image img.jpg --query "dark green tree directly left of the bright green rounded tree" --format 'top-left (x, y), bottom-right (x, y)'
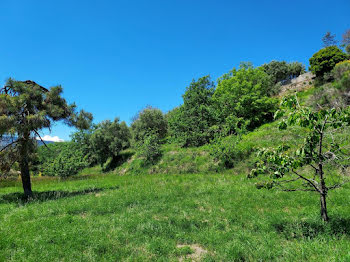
top-left (168, 76), bottom-right (216, 147)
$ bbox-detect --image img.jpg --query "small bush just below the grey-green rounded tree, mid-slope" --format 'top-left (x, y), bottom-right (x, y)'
top-left (138, 133), bottom-right (162, 164)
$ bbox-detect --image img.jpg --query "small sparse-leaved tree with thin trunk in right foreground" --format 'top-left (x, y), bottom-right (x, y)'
top-left (250, 96), bottom-right (350, 221)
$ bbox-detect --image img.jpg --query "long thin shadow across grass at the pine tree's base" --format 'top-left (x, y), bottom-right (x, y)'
top-left (0, 186), bottom-right (119, 205)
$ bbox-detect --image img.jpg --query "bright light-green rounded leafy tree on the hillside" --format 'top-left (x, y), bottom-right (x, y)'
top-left (213, 64), bottom-right (277, 133)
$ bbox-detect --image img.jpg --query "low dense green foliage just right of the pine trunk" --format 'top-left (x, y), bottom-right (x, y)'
top-left (38, 142), bottom-right (89, 177)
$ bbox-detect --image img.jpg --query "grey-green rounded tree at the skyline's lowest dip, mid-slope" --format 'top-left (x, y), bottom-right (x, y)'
top-left (131, 106), bottom-right (168, 143)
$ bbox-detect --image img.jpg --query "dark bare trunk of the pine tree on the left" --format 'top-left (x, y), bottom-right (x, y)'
top-left (19, 132), bottom-right (33, 198)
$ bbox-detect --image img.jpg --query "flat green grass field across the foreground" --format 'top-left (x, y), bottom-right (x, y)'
top-left (0, 172), bottom-right (350, 261)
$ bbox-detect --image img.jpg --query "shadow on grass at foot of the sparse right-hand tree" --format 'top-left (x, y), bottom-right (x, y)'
top-left (272, 217), bottom-right (350, 240)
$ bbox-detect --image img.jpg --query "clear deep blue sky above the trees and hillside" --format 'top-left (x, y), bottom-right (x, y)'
top-left (0, 0), bottom-right (350, 139)
